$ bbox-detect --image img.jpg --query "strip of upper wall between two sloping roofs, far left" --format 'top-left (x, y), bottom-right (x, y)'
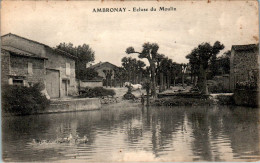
top-left (1, 35), bottom-right (46, 57)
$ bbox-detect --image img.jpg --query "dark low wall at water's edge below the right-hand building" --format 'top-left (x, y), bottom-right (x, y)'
top-left (234, 89), bottom-right (259, 107)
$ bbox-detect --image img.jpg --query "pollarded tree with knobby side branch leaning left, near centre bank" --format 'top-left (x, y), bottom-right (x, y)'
top-left (126, 42), bottom-right (159, 97)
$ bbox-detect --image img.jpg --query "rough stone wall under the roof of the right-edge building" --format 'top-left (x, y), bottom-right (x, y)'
top-left (230, 49), bottom-right (259, 90)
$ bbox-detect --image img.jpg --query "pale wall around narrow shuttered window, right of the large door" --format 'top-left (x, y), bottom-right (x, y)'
top-left (45, 48), bottom-right (78, 95)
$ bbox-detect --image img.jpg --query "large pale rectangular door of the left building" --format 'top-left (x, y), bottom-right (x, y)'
top-left (46, 69), bottom-right (60, 98)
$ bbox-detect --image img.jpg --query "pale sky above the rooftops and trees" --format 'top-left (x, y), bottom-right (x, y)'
top-left (1, 1), bottom-right (259, 66)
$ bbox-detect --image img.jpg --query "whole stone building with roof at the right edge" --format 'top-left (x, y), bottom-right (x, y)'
top-left (230, 44), bottom-right (259, 91)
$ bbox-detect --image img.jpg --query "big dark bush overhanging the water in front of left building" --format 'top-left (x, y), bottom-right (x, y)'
top-left (2, 84), bottom-right (50, 115)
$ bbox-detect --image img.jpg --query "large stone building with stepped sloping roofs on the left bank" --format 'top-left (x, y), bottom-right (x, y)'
top-left (1, 33), bottom-right (78, 98)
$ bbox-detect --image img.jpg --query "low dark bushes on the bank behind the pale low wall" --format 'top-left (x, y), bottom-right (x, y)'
top-left (79, 87), bottom-right (116, 98)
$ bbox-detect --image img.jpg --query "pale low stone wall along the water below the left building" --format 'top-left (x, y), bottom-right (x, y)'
top-left (39, 98), bottom-right (101, 113)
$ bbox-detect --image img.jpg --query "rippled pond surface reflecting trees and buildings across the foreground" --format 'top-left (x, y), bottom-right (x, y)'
top-left (2, 103), bottom-right (260, 161)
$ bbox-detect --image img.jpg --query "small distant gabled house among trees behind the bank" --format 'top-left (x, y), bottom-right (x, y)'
top-left (88, 62), bottom-right (118, 80)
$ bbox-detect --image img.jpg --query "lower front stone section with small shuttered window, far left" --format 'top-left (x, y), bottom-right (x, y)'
top-left (1, 46), bottom-right (47, 86)
